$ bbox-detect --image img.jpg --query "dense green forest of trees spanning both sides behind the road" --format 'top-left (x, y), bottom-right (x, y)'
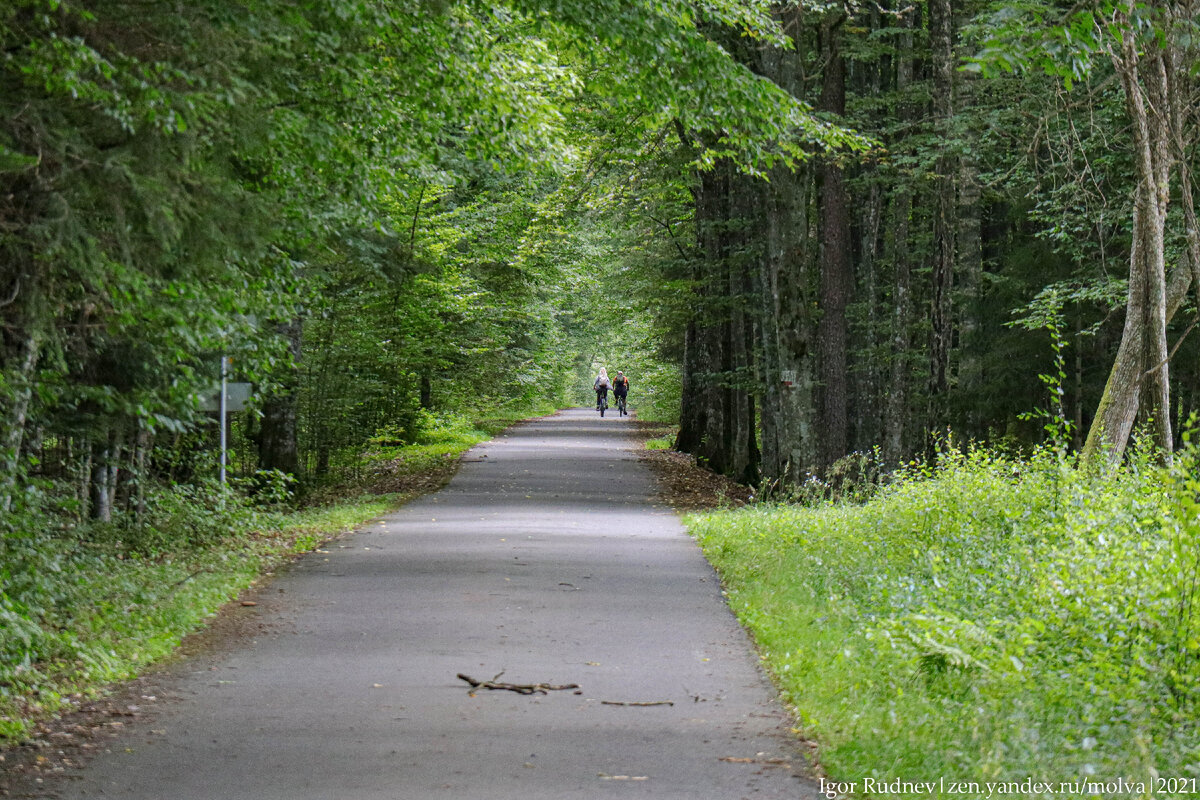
top-left (0, 0), bottom-right (1200, 519)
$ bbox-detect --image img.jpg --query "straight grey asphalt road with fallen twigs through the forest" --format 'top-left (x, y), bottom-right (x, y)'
top-left (16, 410), bottom-right (817, 800)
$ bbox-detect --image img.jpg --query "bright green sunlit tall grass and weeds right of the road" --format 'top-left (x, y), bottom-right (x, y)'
top-left (688, 443), bottom-right (1200, 796)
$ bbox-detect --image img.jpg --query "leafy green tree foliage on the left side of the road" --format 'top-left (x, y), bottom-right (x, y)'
top-left (7, 0), bottom-right (806, 513)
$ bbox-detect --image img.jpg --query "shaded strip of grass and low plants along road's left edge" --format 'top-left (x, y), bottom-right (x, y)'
top-left (0, 415), bottom-right (540, 744)
